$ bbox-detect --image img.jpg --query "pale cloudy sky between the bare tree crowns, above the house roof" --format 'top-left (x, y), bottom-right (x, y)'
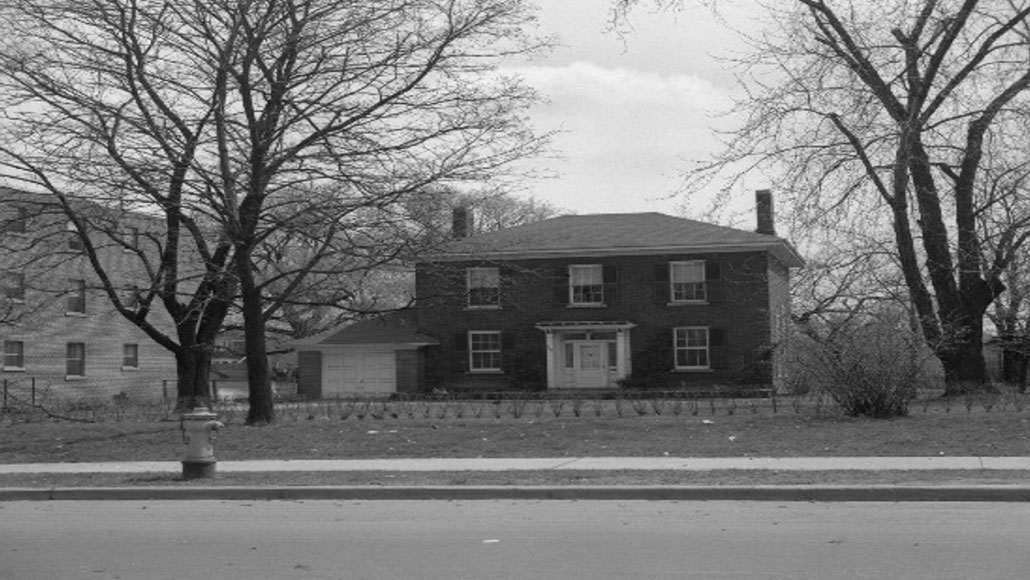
top-left (506, 0), bottom-right (768, 223)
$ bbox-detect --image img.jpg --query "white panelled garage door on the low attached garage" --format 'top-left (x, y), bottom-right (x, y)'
top-left (322, 352), bottom-right (397, 397)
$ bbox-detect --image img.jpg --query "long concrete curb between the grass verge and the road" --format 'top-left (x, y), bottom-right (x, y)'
top-left (0, 485), bottom-right (1030, 502)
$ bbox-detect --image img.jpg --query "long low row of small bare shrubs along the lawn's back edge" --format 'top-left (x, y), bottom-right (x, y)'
top-left (0, 380), bottom-right (1030, 423)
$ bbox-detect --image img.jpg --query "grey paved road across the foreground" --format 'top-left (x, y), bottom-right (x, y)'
top-left (0, 501), bottom-right (1030, 580)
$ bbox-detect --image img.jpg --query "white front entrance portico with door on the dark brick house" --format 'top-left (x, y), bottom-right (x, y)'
top-left (537, 321), bottom-right (633, 388)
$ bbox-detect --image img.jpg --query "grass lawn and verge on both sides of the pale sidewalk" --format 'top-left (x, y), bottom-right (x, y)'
top-left (0, 408), bottom-right (1030, 487)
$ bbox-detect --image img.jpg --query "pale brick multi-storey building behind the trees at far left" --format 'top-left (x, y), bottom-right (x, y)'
top-left (0, 189), bottom-right (176, 400)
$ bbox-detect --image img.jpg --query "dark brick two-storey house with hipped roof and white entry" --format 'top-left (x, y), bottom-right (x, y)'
top-left (301, 191), bottom-right (802, 393)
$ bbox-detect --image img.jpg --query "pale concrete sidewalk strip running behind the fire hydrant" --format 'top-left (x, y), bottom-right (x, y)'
top-left (0, 456), bottom-right (1030, 474)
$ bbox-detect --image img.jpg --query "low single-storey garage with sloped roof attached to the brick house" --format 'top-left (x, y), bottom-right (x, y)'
top-left (295, 312), bottom-right (438, 399)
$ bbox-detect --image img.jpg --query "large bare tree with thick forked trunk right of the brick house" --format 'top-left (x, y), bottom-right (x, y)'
top-left (616, 0), bottom-right (1030, 393)
